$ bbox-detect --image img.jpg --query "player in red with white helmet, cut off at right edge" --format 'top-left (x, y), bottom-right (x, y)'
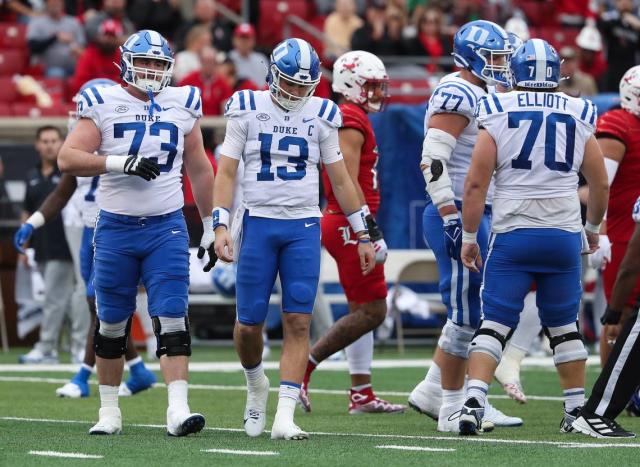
top-left (596, 66), bottom-right (640, 372)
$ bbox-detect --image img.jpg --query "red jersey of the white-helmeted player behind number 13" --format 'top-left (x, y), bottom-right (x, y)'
top-left (322, 103), bottom-right (380, 216)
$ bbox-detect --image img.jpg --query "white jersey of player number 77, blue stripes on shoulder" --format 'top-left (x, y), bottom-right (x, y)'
top-left (424, 73), bottom-right (491, 204)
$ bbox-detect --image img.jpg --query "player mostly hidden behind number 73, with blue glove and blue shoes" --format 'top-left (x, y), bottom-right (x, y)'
top-left (14, 78), bottom-right (156, 399)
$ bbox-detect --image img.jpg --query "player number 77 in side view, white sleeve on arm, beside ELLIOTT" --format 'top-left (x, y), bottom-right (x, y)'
top-left (409, 20), bottom-right (522, 432)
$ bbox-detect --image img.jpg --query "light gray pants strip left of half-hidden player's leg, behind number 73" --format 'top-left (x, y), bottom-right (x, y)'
top-left (64, 226), bottom-right (91, 357)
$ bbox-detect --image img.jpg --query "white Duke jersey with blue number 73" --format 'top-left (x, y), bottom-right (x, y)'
top-left (78, 86), bottom-right (202, 216)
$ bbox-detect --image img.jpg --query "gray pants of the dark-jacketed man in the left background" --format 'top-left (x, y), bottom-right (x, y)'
top-left (36, 260), bottom-right (74, 353)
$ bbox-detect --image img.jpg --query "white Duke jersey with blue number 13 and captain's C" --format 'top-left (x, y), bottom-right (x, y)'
top-left (220, 90), bottom-right (342, 219)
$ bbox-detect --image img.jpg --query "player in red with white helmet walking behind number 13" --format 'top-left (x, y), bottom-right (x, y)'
top-left (300, 51), bottom-right (405, 414)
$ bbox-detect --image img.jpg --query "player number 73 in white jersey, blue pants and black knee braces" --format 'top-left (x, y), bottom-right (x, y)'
top-left (59, 30), bottom-right (216, 436)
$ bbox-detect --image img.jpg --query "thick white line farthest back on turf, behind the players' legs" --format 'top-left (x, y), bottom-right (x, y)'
top-left (0, 355), bottom-right (600, 373)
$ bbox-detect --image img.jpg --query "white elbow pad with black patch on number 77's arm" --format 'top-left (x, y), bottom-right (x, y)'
top-left (420, 128), bottom-right (456, 208)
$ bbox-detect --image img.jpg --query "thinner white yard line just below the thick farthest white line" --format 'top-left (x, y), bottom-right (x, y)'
top-left (0, 376), bottom-right (564, 402)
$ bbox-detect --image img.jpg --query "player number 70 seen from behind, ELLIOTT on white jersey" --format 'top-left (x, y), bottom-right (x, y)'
top-left (459, 39), bottom-right (608, 435)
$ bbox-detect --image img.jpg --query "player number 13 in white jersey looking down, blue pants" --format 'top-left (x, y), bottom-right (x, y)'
top-left (213, 39), bottom-right (375, 440)
